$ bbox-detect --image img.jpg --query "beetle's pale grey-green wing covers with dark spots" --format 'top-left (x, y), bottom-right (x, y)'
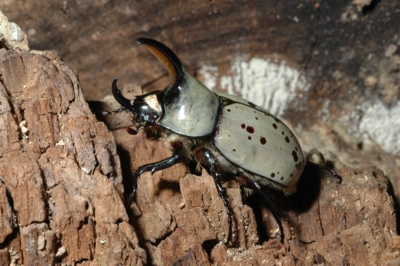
top-left (213, 96), bottom-right (305, 187)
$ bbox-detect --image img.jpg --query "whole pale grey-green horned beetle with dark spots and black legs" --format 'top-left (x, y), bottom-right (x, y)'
top-left (112, 38), bottom-right (340, 242)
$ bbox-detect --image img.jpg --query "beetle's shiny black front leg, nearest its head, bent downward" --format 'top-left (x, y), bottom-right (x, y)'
top-left (125, 150), bottom-right (182, 207)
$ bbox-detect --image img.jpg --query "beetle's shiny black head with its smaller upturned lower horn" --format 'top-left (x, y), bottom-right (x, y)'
top-left (112, 79), bottom-right (162, 134)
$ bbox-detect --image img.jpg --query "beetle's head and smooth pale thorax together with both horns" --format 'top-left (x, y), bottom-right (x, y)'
top-left (112, 38), bottom-right (219, 137)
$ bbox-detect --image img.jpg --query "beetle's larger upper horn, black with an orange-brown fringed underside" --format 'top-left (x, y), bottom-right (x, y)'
top-left (136, 38), bottom-right (184, 83)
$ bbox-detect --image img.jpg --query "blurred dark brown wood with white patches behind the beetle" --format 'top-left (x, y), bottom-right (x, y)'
top-left (0, 0), bottom-right (400, 207)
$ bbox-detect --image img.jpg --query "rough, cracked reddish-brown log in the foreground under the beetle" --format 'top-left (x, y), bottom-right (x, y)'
top-left (0, 46), bottom-right (400, 265)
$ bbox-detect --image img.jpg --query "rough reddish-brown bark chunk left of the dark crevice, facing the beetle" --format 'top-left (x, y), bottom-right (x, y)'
top-left (0, 49), bottom-right (146, 265)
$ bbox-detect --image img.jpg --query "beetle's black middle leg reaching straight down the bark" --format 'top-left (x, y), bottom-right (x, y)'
top-left (203, 149), bottom-right (232, 242)
